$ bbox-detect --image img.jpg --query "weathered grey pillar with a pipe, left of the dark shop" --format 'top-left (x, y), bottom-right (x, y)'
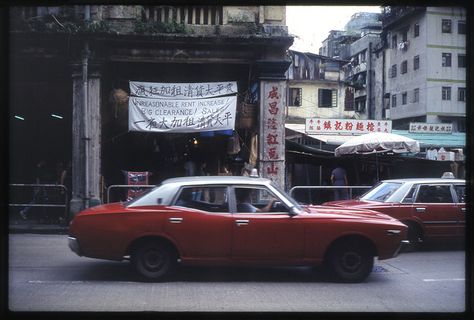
top-left (70, 57), bottom-right (101, 218)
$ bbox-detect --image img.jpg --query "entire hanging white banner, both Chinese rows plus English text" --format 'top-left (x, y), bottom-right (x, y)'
top-left (128, 81), bottom-right (237, 132)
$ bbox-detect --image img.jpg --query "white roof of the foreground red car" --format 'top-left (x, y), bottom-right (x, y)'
top-left (161, 176), bottom-right (271, 185)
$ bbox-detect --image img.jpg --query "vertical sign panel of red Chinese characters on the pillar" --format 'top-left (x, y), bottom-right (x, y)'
top-left (260, 82), bottom-right (285, 186)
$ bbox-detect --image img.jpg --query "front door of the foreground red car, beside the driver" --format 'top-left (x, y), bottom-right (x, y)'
top-left (232, 186), bottom-right (304, 263)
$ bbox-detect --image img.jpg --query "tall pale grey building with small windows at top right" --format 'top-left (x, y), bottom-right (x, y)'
top-left (383, 7), bottom-right (467, 132)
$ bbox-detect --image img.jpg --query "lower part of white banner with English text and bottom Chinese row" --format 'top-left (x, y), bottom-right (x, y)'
top-left (128, 95), bottom-right (237, 132)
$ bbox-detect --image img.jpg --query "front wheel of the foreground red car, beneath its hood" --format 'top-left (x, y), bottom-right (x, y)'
top-left (328, 240), bottom-right (374, 282)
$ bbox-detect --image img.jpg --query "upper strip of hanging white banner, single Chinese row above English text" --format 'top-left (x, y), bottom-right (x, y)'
top-left (130, 81), bottom-right (237, 99)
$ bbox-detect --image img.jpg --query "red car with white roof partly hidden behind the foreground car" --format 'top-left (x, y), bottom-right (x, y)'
top-left (323, 178), bottom-right (466, 244)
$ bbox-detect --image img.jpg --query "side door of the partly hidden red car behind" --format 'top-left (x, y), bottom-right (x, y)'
top-left (412, 184), bottom-right (459, 238)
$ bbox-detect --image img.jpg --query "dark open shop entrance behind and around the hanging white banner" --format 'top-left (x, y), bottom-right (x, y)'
top-left (102, 63), bottom-right (256, 200)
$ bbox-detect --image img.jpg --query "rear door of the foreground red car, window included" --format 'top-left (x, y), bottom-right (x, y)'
top-left (165, 186), bottom-right (233, 260)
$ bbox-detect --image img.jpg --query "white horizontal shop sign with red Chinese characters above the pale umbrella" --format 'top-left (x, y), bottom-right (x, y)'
top-left (305, 118), bottom-right (392, 135)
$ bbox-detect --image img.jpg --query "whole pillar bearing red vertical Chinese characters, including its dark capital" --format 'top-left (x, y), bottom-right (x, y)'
top-left (256, 60), bottom-right (290, 189)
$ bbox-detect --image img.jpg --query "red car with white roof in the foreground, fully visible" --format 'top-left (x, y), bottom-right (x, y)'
top-left (69, 176), bottom-right (407, 282)
